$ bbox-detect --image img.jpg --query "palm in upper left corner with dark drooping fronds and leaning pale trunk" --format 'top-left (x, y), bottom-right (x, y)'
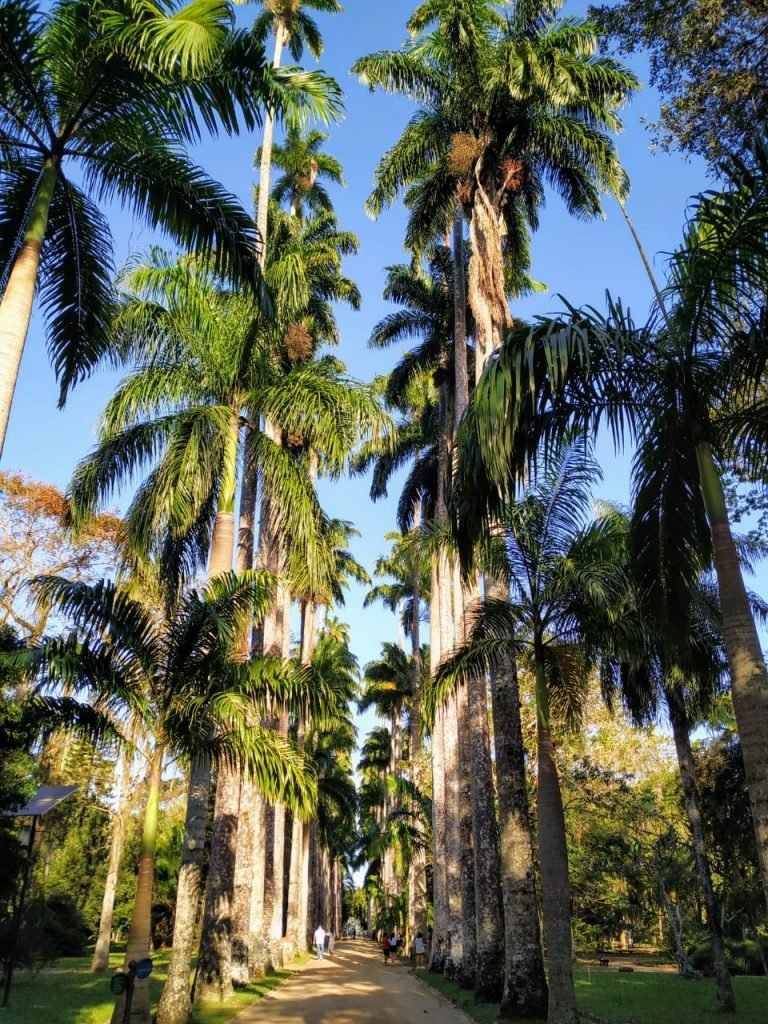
top-left (0, 0), bottom-right (338, 450)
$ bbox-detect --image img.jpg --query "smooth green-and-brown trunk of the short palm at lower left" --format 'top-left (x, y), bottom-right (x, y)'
top-left (112, 745), bottom-right (165, 1024)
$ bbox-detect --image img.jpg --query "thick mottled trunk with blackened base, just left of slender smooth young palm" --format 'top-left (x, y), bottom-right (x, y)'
top-left (485, 577), bottom-right (547, 1019)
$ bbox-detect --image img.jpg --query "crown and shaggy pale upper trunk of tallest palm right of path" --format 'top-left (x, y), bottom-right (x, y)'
top-left (352, 0), bottom-right (638, 359)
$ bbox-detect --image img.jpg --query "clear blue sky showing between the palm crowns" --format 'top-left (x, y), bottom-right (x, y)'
top-left (3, 0), bottom-right (765, 679)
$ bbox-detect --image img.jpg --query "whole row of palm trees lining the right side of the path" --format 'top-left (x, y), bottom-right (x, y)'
top-left (354, 8), bottom-right (768, 1024)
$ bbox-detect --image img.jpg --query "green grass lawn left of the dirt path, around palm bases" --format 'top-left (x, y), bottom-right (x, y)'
top-left (0, 951), bottom-right (306, 1024)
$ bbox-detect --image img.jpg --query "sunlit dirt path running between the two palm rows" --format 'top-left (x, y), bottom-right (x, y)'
top-left (236, 939), bottom-right (468, 1024)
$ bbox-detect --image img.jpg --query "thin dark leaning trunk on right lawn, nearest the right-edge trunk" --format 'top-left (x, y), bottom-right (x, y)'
top-left (665, 688), bottom-right (735, 1013)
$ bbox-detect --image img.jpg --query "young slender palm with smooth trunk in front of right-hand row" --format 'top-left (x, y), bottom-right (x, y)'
top-left (440, 440), bottom-right (628, 1024)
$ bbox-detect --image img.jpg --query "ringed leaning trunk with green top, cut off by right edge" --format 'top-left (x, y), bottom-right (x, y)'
top-left (696, 442), bottom-right (768, 905)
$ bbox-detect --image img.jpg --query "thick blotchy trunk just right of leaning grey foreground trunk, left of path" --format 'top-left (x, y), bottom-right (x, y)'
top-left (195, 765), bottom-right (240, 1002)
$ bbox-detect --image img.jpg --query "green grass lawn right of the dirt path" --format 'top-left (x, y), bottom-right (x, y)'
top-left (416, 967), bottom-right (768, 1024)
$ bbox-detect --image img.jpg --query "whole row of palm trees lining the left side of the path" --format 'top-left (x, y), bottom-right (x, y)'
top-left (0, 0), bottom-right (387, 1024)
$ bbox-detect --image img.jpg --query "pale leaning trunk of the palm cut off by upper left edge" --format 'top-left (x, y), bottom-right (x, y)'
top-left (0, 158), bottom-right (58, 457)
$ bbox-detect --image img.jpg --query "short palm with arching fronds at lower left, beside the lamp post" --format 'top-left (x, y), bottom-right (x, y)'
top-left (26, 572), bottom-right (315, 1024)
